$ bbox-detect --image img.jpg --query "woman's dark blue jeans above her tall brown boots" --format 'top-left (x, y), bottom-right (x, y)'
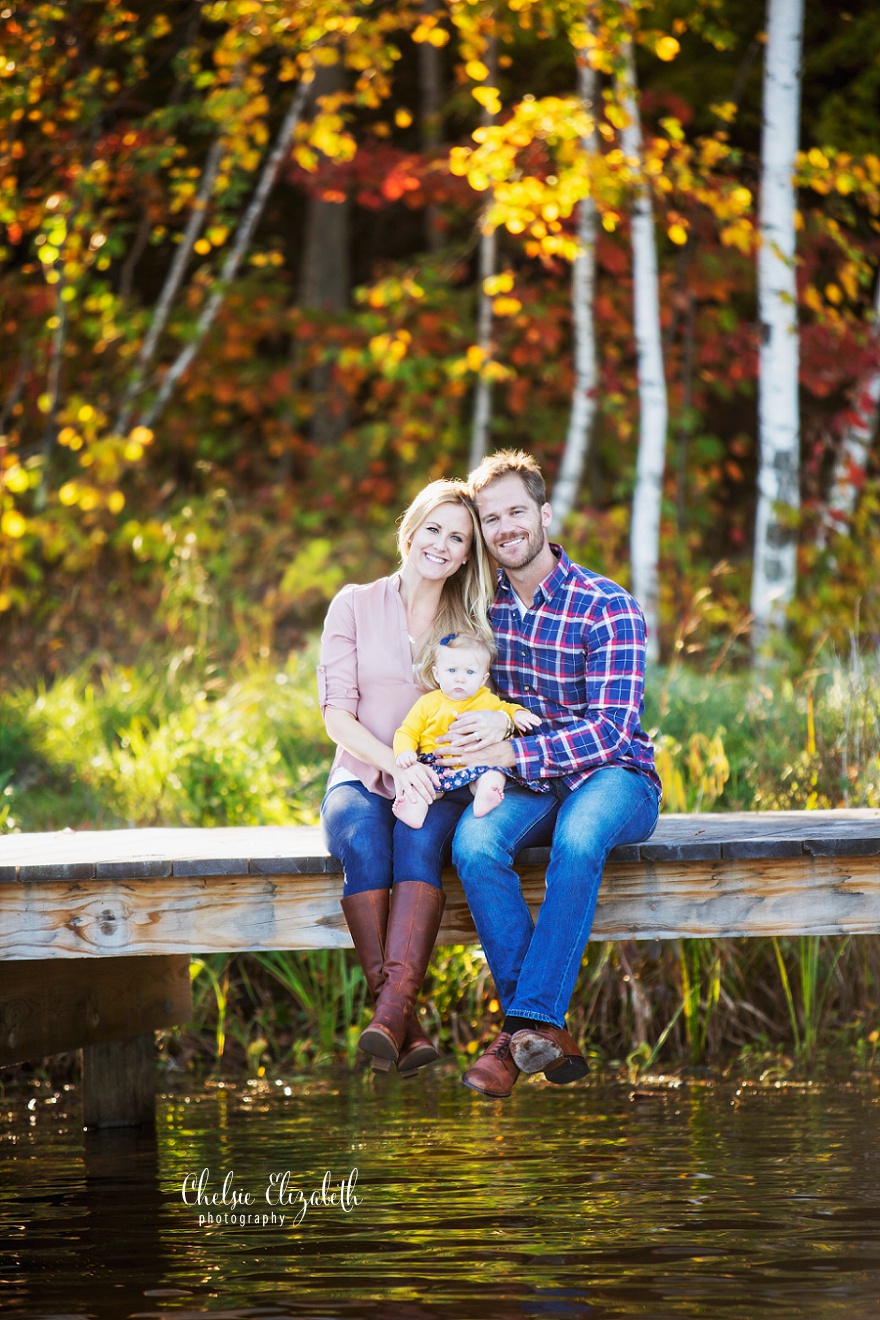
top-left (321, 780), bottom-right (474, 898)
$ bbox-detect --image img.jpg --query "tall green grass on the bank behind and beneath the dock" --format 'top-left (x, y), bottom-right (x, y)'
top-left (0, 643), bottom-right (880, 1076)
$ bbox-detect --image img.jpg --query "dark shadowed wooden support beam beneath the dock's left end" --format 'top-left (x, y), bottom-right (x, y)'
top-left (0, 956), bottom-right (193, 1065)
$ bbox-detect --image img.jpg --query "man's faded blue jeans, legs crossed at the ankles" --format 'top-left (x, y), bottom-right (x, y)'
top-left (453, 766), bottom-right (660, 1027)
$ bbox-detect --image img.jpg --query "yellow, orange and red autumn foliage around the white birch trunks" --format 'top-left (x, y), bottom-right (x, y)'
top-left (0, 0), bottom-right (880, 671)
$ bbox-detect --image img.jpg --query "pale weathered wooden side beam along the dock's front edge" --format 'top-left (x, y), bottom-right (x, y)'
top-left (0, 855), bottom-right (880, 960)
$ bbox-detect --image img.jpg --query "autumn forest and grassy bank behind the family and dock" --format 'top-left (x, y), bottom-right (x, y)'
top-left (0, 0), bottom-right (880, 1072)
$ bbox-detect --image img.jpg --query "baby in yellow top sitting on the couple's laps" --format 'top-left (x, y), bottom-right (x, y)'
top-left (392, 632), bottom-right (541, 829)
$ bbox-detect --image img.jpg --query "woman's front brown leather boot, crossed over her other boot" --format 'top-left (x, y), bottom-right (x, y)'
top-left (359, 880), bottom-right (446, 1067)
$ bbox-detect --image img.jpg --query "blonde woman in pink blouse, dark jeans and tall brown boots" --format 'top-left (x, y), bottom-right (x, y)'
top-left (318, 480), bottom-right (505, 1076)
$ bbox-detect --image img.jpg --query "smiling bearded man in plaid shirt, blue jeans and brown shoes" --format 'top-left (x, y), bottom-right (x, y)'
top-left (440, 450), bottom-right (661, 1098)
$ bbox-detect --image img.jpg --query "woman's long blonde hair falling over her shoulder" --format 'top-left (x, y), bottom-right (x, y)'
top-left (397, 478), bottom-right (495, 686)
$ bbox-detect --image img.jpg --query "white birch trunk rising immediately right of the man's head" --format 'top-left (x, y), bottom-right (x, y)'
top-left (550, 57), bottom-right (599, 536)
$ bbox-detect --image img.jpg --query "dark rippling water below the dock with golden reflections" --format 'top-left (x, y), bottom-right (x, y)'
top-left (0, 1076), bottom-right (880, 1320)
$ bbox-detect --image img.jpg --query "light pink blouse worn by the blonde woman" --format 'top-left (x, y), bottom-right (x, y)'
top-left (318, 573), bottom-right (425, 797)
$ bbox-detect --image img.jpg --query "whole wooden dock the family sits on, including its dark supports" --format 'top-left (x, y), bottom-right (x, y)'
top-left (0, 810), bottom-right (880, 1125)
